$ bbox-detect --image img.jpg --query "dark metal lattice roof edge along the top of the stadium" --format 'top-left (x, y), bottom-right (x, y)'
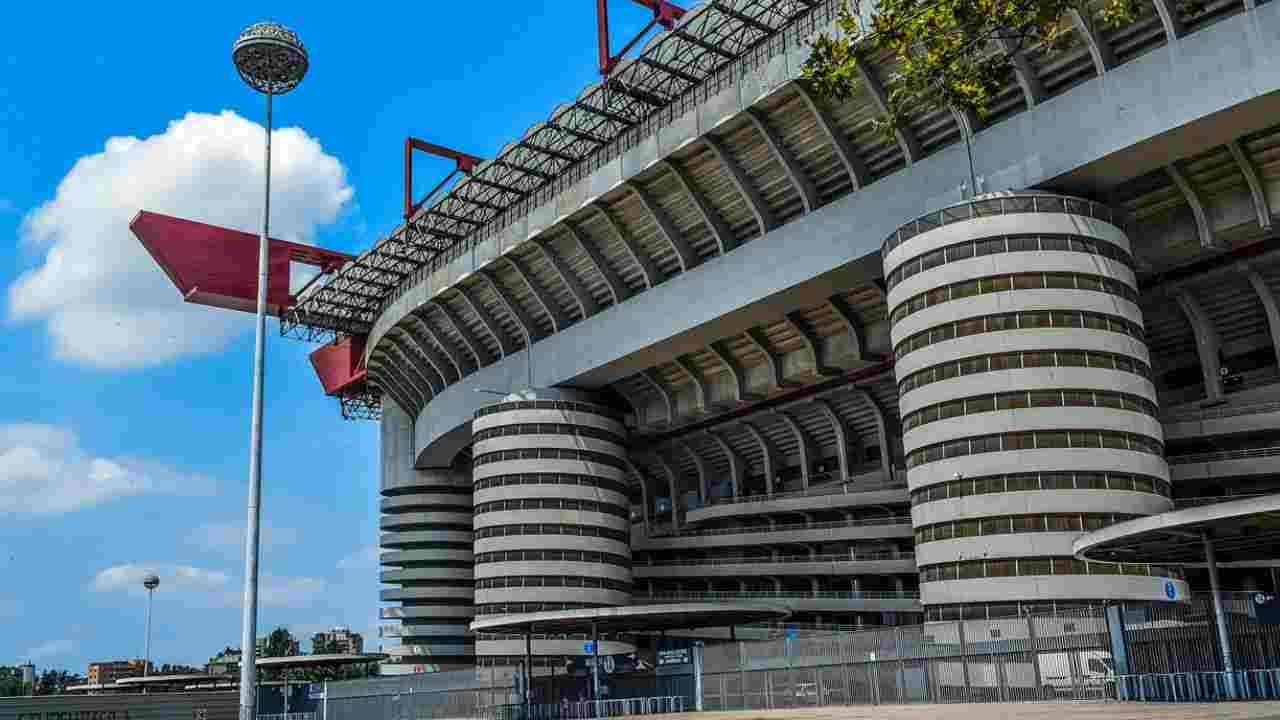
top-left (280, 0), bottom-right (831, 340)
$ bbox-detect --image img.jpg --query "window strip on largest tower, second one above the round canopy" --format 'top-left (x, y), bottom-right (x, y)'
top-left (906, 429), bottom-right (1165, 469)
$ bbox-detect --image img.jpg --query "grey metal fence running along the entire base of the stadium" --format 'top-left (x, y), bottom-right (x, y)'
top-left (323, 593), bottom-right (1280, 720)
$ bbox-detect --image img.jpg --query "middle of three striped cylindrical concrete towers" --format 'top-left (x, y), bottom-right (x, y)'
top-left (472, 389), bottom-right (631, 655)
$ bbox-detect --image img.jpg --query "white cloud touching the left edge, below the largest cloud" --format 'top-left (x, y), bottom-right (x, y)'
top-left (0, 423), bottom-right (214, 515)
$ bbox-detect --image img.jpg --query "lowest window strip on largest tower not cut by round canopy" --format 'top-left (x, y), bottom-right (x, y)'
top-left (911, 470), bottom-right (1172, 505)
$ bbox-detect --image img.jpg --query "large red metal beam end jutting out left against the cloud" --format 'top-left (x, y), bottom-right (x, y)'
top-left (129, 210), bottom-right (353, 315)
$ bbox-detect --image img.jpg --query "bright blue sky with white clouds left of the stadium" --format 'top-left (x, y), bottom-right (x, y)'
top-left (0, 0), bottom-right (646, 673)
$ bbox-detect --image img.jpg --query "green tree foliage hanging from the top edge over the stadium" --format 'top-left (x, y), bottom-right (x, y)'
top-left (803, 0), bottom-right (1204, 131)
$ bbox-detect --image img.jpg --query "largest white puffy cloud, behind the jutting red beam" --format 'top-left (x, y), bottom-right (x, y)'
top-left (9, 110), bottom-right (353, 368)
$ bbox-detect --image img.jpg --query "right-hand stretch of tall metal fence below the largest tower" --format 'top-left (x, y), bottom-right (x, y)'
top-left (703, 593), bottom-right (1280, 710)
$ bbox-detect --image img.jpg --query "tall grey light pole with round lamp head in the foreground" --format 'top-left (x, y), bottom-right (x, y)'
top-left (232, 23), bottom-right (308, 720)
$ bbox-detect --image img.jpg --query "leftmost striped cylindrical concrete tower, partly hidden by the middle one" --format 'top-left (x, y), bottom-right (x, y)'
top-left (380, 397), bottom-right (475, 673)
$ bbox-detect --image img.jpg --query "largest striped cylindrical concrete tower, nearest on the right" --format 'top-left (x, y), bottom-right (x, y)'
top-left (882, 193), bottom-right (1187, 620)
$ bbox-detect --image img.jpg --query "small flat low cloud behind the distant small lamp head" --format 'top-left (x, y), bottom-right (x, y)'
top-left (90, 562), bottom-right (325, 609)
